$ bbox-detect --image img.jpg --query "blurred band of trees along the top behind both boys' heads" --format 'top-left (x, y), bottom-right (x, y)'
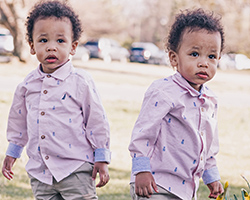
top-left (0, 0), bottom-right (250, 60)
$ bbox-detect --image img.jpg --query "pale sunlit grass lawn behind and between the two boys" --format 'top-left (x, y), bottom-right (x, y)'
top-left (0, 59), bottom-right (250, 200)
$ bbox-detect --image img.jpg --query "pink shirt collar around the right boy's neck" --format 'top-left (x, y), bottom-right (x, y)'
top-left (173, 71), bottom-right (216, 97)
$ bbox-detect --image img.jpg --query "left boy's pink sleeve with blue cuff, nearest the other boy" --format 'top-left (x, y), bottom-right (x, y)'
top-left (79, 74), bottom-right (111, 163)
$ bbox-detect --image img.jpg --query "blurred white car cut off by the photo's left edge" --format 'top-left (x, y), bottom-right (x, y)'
top-left (0, 28), bottom-right (14, 55)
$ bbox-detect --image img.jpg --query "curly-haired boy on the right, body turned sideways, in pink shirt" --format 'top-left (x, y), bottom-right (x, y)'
top-left (129, 9), bottom-right (224, 200)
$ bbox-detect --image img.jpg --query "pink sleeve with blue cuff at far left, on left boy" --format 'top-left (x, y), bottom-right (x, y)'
top-left (6, 84), bottom-right (28, 158)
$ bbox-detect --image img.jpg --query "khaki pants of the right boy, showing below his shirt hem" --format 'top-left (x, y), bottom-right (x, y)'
top-left (130, 183), bottom-right (181, 200)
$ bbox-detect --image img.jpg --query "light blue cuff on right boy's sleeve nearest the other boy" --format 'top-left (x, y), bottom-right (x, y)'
top-left (132, 157), bottom-right (151, 175)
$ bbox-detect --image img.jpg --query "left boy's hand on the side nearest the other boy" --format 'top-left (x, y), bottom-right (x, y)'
top-left (92, 162), bottom-right (109, 187)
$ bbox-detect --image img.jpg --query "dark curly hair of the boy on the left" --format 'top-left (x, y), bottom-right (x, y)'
top-left (26, 0), bottom-right (82, 42)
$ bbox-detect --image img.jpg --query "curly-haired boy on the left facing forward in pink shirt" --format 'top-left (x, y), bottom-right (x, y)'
top-left (2, 1), bottom-right (110, 200)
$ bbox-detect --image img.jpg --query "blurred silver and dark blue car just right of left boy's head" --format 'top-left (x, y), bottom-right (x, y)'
top-left (84, 38), bottom-right (129, 62)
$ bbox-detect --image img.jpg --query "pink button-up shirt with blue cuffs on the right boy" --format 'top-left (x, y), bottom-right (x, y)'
top-left (129, 72), bottom-right (220, 200)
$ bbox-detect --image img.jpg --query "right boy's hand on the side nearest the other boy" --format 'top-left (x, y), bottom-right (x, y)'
top-left (135, 172), bottom-right (159, 198)
